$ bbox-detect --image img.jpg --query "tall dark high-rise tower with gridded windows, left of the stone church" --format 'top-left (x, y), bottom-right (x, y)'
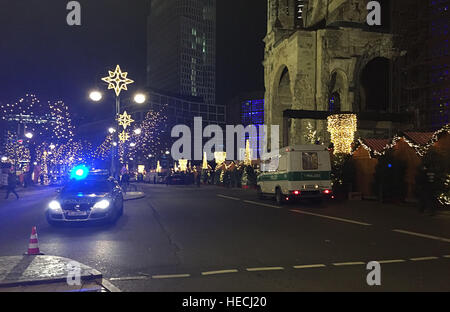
top-left (147, 0), bottom-right (225, 123)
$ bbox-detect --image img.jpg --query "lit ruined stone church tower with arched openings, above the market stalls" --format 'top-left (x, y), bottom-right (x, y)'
top-left (264, 0), bottom-right (397, 146)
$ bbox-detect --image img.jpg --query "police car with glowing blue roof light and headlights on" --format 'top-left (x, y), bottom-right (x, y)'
top-left (46, 166), bottom-right (123, 225)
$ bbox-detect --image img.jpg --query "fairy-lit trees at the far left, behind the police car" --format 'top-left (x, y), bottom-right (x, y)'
top-left (0, 94), bottom-right (93, 176)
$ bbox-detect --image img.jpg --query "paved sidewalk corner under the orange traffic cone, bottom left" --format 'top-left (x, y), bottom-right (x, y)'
top-left (0, 255), bottom-right (110, 292)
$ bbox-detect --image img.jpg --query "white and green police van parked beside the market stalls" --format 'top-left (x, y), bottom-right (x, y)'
top-left (257, 145), bottom-right (334, 205)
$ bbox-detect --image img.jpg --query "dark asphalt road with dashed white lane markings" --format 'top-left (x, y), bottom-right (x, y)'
top-left (0, 185), bottom-right (450, 291)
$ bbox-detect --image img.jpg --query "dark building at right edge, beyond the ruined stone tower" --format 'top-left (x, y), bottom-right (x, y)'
top-left (393, 0), bottom-right (450, 131)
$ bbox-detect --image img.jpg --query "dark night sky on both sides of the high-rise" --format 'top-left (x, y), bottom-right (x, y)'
top-left (0, 0), bottom-right (266, 122)
